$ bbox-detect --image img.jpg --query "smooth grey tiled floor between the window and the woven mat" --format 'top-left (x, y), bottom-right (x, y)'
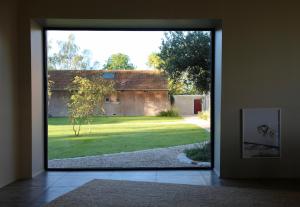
top-left (0, 170), bottom-right (300, 207)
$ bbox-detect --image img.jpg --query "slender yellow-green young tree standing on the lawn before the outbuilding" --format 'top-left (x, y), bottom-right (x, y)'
top-left (68, 76), bottom-right (114, 136)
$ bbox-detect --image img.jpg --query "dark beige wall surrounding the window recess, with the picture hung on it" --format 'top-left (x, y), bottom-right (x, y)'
top-left (10, 0), bottom-right (300, 178)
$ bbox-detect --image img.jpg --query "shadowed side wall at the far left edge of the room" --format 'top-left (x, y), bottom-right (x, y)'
top-left (0, 0), bottom-right (18, 187)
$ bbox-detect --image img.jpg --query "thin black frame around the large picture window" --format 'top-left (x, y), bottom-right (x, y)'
top-left (42, 27), bottom-right (216, 171)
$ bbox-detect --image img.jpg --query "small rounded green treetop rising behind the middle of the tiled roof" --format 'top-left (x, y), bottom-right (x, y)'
top-left (103, 53), bottom-right (135, 70)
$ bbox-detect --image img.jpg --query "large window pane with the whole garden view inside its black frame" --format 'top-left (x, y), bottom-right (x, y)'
top-left (45, 30), bottom-right (213, 169)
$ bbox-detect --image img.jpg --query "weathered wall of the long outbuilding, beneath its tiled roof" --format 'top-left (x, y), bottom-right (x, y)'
top-left (48, 91), bottom-right (169, 117)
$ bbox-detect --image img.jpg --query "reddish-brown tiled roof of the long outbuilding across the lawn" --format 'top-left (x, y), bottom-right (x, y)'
top-left (48, 70), bottom-right (168, 90)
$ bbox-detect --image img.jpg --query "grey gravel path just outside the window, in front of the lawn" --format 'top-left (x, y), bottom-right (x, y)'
top-left (48, 144), bottom-right (210, 168)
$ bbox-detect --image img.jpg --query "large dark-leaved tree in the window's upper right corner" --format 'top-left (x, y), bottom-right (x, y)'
top-left (158, 31), bottom-right (211, 93)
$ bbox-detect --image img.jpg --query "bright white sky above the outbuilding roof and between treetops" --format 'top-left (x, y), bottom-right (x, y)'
top-left (47, 30), bottom-right (168, 70)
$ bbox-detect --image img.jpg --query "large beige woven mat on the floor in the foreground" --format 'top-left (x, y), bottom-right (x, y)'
top-left (46, 180), bottom-right (300, 207)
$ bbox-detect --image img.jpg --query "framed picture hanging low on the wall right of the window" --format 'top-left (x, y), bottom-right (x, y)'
top-left (242, 108), bottom-right (281, 158)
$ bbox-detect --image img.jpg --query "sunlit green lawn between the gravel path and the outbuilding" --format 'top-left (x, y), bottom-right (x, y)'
top-left (48, 116), bottom-right (209, 159)
